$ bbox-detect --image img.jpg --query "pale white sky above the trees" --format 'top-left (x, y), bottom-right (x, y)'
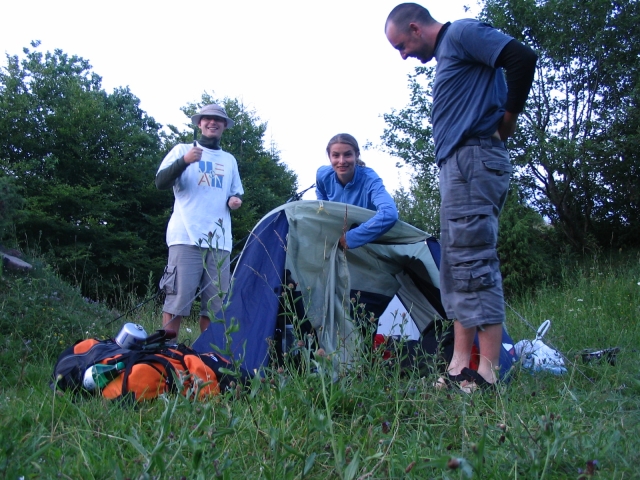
top-left (0, 0), bottom-right (479, 199)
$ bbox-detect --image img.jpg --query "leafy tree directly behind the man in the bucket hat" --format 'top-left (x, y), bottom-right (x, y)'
top-left (164, 92), bottom-right (297, 253)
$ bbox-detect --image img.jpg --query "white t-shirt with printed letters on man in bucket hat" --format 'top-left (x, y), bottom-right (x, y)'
top-left (158, 144), bottom-right (244, 252)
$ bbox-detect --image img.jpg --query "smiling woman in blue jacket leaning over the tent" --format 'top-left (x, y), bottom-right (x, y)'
top-left (316, 133), bottom-right (398, 250)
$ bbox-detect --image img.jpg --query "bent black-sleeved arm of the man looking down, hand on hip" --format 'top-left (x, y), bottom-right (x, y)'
top-left (494, 40), bottom-right (538, 141)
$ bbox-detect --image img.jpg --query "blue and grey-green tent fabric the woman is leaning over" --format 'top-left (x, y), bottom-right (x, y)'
top-left (193, 200), bottom-right (516, 371)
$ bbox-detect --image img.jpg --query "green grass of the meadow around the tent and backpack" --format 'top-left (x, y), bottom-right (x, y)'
top-left (0, 252), bottom-right (640, 479)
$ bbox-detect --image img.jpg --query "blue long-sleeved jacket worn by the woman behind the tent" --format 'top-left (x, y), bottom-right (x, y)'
top-left (316, 165), bottom-right (398, 248)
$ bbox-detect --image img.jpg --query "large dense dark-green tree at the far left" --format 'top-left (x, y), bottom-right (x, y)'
top-left (0, 42), bottom-right (170, 298)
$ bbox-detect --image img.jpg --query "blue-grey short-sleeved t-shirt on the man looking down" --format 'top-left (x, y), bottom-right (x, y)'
top-left (431, 19), bottom-right (513, 165)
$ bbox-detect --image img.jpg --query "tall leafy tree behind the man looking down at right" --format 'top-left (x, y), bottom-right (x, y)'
top-left (382, 0), bottom-right (640, 291)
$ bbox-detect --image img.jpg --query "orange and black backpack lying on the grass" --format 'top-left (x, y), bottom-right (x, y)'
top-left (51, 338), bottom-right (247, 401)
